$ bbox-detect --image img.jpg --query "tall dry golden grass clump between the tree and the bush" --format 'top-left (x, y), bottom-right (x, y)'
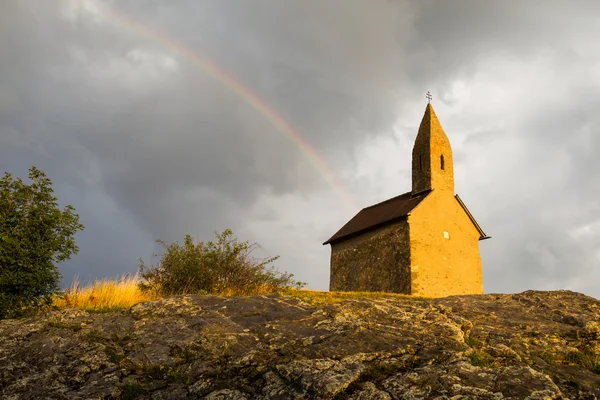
top-left (53, 274), bottom-right (157, 311)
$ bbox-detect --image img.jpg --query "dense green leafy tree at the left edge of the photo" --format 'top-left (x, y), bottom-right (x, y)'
top-left (0, 167), bottom-right (84, 319)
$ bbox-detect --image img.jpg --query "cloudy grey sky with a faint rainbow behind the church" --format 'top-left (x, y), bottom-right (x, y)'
top-left (0, 0), bottom-right (600, 298)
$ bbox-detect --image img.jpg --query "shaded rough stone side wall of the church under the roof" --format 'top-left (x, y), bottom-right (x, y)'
top-left (329, 220), bottom-right (411, 294)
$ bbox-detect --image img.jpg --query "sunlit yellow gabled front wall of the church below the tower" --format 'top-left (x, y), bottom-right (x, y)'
top-left (408, 189), bottom-right (483, 297)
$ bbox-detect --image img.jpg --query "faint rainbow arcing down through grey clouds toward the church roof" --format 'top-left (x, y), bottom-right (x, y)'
top-left (70, 0), bottom-right (359, 211)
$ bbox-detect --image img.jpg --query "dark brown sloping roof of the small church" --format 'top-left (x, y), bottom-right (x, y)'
top-left (323, 190), bottom-right (431, 245)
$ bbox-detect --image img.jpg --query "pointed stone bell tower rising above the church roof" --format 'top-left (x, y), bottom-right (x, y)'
top-left (412, 104), bottom-right (454, 195)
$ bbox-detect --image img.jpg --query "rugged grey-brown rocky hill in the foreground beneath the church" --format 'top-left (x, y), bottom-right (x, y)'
top-left (0, 291), bottom-right (600, 400)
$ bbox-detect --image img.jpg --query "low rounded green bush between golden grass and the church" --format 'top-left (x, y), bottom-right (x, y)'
top-left (139, 229), bottom-right (305, 296)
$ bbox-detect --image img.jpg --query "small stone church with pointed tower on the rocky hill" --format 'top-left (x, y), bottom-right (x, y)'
top-left (323, 104), bottom-right (489, 297)
